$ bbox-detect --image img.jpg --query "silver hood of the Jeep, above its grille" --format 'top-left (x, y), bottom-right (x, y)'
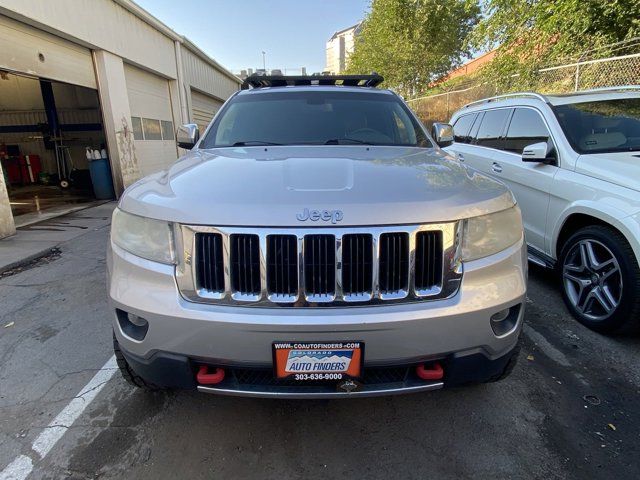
top-left (120, 146), bottom-right (514, 227)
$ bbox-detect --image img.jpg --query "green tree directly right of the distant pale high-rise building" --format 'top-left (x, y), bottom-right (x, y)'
top-left (347, 0), bottom-right (480, 96)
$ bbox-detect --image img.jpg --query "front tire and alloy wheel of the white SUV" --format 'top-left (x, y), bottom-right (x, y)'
top-left (559, 225), bottom-right (640, 333)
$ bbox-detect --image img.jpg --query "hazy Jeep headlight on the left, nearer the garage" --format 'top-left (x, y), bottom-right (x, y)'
top-left (111, 208), bottom-right (175, 264)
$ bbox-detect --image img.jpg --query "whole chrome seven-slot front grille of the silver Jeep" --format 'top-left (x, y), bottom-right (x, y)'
top-left (176, 222), bottom-right (462, 307)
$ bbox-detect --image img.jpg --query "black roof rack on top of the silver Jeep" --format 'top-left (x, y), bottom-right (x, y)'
top-left (242, 72), bottom-right (384, 90)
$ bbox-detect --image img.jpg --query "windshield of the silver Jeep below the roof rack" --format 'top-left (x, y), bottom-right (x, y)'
top-left (200, 90), bottom-right (433, 148)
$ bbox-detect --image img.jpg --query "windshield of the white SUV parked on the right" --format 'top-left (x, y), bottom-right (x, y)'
top-left (553, 98), bottom-right (640, 154)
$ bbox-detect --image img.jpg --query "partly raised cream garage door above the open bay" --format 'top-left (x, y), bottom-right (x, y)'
top-left (0, 15), bottom-right (98, 89)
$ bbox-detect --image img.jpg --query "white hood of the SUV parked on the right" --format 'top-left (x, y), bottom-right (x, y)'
top-left (576, 151), bottom-right (640, 191)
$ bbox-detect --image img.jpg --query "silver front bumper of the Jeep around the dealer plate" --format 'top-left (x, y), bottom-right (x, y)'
top-left (108, 237), bottom-right (527, 396)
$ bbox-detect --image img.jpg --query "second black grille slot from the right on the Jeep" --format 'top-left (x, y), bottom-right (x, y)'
top-left (379, 232), bottom-right (409, 294)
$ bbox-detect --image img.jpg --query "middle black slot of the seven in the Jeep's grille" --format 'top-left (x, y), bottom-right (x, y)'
top-left (304, 235), bottom-right (336, 297)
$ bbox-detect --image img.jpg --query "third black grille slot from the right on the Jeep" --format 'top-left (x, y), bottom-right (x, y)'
top-left (342, 234), bottom-right (373, 295)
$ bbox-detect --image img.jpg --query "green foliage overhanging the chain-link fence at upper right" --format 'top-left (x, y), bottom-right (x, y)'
top-left (470, 0), bottom-right (640, 89)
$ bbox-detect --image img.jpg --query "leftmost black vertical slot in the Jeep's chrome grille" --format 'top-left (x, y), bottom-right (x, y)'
top-left (195, 233), bottom-right (225, 293)
